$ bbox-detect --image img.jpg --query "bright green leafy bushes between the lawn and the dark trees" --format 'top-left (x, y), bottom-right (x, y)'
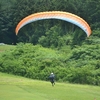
top-left (0, 43), bottom-right (100, 85)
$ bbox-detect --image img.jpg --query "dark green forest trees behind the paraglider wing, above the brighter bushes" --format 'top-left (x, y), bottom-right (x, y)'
top-left (0, 0), bottom-right (100, 44)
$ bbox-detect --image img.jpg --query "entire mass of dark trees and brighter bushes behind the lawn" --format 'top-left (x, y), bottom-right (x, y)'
top-left (0, 0), bottom-right (100, 85)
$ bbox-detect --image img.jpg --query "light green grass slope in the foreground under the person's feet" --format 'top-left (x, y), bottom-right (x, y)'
top-left (0, 73), bottom-right (100, 100)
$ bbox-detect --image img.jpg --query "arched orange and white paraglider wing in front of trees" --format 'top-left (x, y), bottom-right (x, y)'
top-left (15, 11), bottom-right (91, 36)
